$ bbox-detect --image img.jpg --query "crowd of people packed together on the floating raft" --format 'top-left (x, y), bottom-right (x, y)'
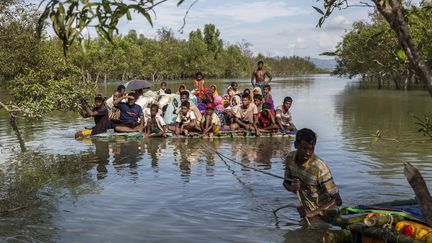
top-left (75, 62), bottom-right (296, 138)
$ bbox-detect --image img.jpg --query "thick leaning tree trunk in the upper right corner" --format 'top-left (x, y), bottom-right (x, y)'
top-left (373, 0), bottom-right (432, 96)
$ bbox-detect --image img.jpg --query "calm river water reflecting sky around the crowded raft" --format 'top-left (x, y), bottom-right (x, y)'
top-left (0, 75), bottom-right (432, 242)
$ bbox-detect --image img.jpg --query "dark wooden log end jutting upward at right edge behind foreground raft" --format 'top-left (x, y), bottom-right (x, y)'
top-left (404, 162), bottom-right (432, 227)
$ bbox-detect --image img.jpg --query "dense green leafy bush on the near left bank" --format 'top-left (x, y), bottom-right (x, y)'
top-left (0, 1), bottom-right (96, 117)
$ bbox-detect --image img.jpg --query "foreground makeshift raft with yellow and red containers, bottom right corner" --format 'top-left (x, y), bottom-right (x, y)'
top-left (323, 200), bottom-right (432, 243)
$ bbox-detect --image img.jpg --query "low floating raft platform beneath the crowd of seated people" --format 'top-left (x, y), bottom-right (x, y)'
top-left (90, 131), bottom-right (295, 140)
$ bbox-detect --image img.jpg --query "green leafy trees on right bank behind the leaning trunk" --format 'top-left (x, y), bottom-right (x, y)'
top-left (325, 3), bottom-right (432, 89)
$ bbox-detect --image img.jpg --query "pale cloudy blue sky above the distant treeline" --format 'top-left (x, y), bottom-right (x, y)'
top-left (32, 0), bottom-right (371, 58)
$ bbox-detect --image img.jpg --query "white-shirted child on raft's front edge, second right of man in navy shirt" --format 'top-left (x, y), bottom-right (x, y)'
top-left (175, 101), bottom-right (201, 136)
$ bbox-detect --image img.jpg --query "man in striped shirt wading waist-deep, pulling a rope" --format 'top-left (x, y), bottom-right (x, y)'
top-left (283, 128), bottom-right (342, 223)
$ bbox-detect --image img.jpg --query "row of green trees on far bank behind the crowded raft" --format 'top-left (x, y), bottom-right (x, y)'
top-left (63, 25), bottom-right (319, 81)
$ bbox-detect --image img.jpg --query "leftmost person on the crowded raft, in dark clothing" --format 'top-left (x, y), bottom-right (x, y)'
top-left (75, 94), bottom-right (109, 139)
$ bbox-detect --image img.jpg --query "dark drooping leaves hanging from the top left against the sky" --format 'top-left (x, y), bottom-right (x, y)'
top-left (38, 0), bottom-right (184, 55)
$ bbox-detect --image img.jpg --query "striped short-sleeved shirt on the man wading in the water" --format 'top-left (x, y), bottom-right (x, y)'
top-left (285, 151), bottom-right (339, 211)
